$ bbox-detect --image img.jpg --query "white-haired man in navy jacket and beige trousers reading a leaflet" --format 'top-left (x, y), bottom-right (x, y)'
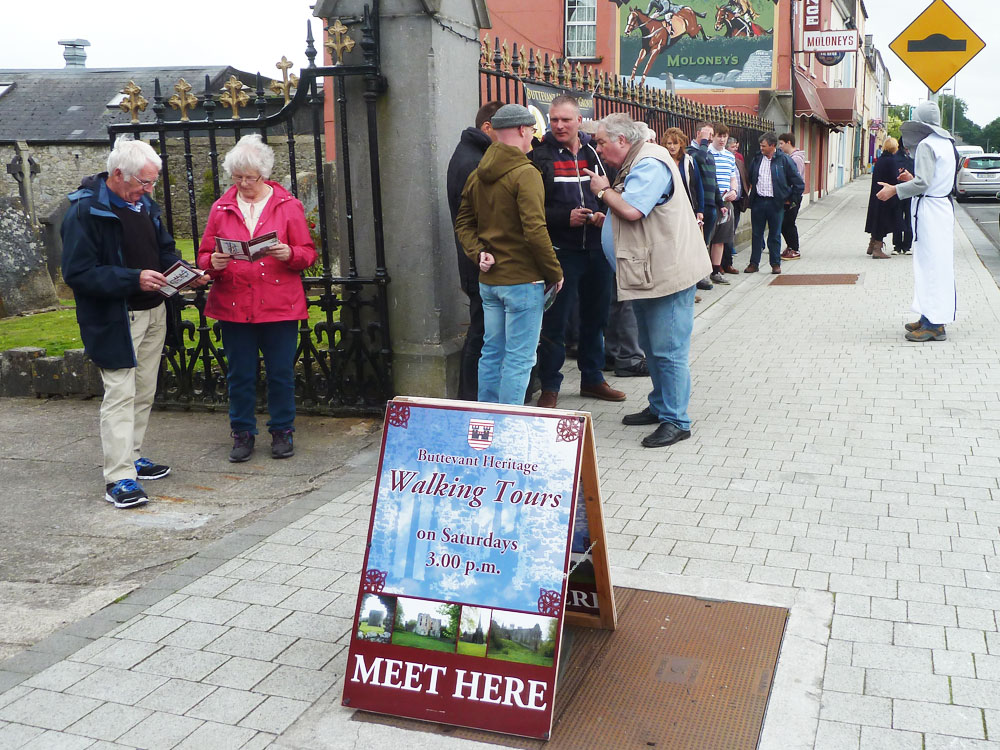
top-left (62, 139), bottom-right (208, 508)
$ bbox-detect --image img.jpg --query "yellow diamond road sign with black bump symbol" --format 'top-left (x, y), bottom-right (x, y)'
top-left (889, 0), bottom-right (986, 91)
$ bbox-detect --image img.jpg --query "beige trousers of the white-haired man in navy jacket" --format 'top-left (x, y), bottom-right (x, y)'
top-left (101, 305), bottom-right (167, 484)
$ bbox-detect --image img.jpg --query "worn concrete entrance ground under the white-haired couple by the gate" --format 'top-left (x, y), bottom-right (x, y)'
top-left (0, 398), bottom-right (381, 659)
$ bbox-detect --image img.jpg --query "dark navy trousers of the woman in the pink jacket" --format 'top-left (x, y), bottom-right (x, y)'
top-left (219, 320), bottom-right (299, 435)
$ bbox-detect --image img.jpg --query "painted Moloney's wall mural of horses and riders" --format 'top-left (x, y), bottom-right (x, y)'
top-left (611, 0), bottom-right (777, 90)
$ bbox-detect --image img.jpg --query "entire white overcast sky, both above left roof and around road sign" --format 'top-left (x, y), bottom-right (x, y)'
top-left (0, 0), bottom-right (1000, 125)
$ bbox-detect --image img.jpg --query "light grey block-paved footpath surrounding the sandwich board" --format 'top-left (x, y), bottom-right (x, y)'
top-left (0, 180), bottom-right (1000, 750)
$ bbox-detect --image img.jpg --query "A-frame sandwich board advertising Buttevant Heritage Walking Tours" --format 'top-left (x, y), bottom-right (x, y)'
top-left (343, 398), bottom-right (616, 739)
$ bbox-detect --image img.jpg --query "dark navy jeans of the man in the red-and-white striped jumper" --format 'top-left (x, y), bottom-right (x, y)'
top-left (538, 248), bottom-right (614, 392)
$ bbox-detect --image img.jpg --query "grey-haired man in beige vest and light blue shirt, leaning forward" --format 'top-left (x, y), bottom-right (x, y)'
top-left (588, 113), bottom-right (711, 448)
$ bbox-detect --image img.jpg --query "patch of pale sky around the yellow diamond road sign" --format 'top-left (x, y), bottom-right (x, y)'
top-left (865, 0), bottom-right (1000, 126)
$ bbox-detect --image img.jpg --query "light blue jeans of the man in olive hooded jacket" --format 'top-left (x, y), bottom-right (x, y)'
top-left (479, 282), bottom-right (545, 406)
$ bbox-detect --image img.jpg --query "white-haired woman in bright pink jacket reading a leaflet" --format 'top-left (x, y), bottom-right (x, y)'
top-left (198, 135), bottom-right (316, 462)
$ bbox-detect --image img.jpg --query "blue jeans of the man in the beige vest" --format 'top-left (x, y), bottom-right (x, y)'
top-left (632, 286), bottom-right (695, 430)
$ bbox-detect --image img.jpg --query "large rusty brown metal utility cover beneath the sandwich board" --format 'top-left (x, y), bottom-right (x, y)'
top-left (354, 588), bottom-right (788, 750)
